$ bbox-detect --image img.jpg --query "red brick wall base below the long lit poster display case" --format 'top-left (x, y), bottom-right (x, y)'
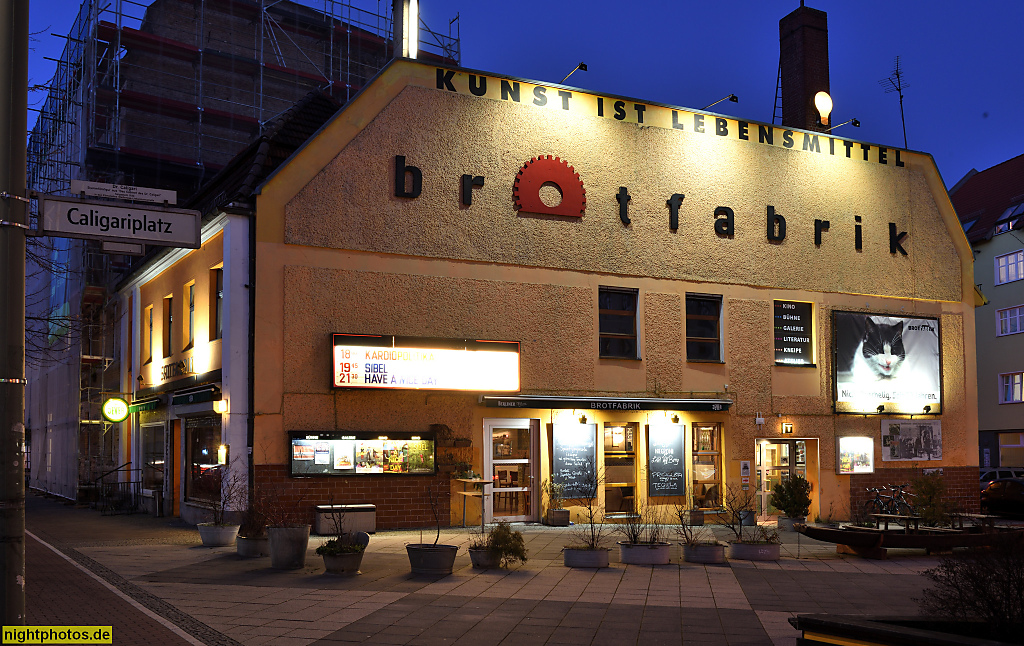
top-left (255, 465), bottom-right (450, 529)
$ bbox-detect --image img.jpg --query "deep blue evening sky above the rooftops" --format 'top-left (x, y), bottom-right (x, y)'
top-left (29, 0), bottom-right (1024, 186)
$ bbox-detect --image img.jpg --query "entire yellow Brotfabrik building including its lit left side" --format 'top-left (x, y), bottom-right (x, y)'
top-left (120, 54), bottom-right (978, 527)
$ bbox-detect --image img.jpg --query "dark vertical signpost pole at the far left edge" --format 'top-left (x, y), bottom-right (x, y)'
top-left (0, 0), bottom-right (29, 626)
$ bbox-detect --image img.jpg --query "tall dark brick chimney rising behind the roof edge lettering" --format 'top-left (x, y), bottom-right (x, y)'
top-left (778, 0), bottom-right (830, 130)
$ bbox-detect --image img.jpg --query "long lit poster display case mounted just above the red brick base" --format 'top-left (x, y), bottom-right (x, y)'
top-left (289, 431), bottom-right (436, 477)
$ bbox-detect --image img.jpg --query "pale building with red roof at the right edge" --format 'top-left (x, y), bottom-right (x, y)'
top-left (949, 155), bottom-right (1024, 470)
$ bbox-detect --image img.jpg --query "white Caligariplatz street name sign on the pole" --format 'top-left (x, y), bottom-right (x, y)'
top-left (39, 196), bottom-right (202, 249)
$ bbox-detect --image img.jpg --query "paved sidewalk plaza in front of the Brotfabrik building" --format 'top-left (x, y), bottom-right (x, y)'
top-left (26, 492), bottom-right (937, 646)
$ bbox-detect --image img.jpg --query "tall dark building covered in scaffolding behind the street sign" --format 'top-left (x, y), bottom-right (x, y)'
top-left (27, 0), bottom-right (461, 499)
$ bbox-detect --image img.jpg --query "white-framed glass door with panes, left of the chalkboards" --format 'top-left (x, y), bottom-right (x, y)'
top-left (483, 419), bottom-right (541, 521)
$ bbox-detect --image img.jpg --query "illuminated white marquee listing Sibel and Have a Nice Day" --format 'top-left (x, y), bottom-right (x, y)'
top-left (333, 334), bottom-right (519, 392)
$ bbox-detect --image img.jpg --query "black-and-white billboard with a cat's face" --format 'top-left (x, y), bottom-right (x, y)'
top-left (833, 311), bottom-right (942, 415)
